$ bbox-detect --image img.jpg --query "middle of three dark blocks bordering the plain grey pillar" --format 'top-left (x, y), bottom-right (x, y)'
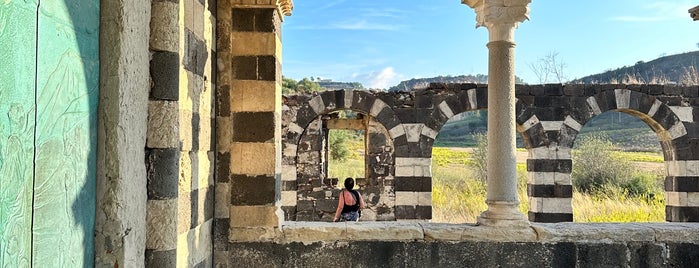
top-left (146, 148), bottom-right (180, 200)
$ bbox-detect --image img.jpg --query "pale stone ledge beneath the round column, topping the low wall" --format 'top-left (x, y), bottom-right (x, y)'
top-left (276, 222), bottom-right (699, 244)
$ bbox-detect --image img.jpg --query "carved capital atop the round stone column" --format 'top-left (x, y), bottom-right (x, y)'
top-left (461, 0), bottom-right (531, 27)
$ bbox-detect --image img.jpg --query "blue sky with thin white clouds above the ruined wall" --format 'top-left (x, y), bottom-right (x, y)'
top-left (282, 0), bottom-right (699, 88)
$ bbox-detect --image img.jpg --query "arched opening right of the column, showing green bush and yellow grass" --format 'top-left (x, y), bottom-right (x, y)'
top-left (571, 110), bottom-right (666, 222)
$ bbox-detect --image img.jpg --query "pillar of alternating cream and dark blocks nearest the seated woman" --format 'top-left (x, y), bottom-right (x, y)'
top-left (214, 0), bottom-right (292, 258)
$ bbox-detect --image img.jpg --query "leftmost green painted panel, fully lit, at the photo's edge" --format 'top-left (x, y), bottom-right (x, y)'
top-left (0, 0), bottom-right (37, 267)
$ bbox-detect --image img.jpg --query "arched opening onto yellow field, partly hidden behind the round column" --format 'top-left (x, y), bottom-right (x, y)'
top-left (432, 110), bottom-right (529, 223)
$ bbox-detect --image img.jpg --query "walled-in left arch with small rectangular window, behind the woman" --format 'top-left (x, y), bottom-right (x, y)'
top-left (283, 105), bottom-right (395, 221)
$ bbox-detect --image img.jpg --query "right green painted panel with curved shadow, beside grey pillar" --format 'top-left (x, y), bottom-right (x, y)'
top-left (33, 0), bottom-right (99, 267)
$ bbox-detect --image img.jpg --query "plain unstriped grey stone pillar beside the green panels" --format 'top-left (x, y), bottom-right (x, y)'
top-left (95, 0), bottom-right (151, 267)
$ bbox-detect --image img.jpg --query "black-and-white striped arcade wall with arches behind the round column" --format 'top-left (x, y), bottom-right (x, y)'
top-left (283, 83), bottom-right (699, 222)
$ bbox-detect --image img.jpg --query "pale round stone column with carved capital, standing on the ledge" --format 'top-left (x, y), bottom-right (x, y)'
top-left (462, 0), bottom-right (531, 226)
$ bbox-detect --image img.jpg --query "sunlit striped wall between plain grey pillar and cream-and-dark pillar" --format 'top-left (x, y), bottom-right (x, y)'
top-left (145, 0), bottom-right (216, 267)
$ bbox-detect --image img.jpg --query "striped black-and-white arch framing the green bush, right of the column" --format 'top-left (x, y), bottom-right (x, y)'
top-left (518, 89), bottom-right (692, 222)
